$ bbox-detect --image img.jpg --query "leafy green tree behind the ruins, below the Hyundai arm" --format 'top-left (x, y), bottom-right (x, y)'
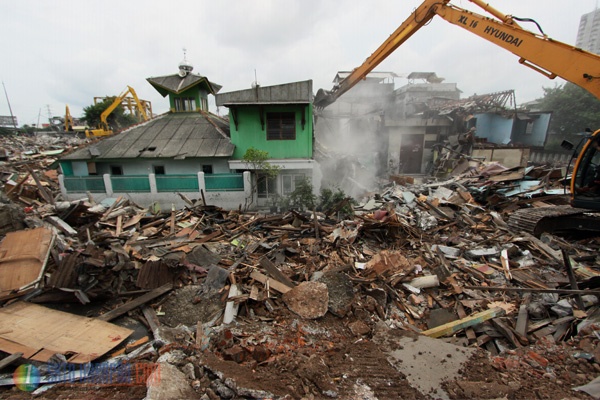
top-left (539, 83), bottom-right (600, 148)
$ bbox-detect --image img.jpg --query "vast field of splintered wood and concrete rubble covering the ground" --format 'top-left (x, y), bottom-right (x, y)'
top-left (0, 133), bottom-right (600, 399)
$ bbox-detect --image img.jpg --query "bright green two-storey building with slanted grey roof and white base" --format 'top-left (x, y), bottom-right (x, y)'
top-left (215, 80), bottom-right (321, 206)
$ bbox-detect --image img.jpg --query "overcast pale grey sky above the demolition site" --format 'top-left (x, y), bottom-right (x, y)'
top-left (0, 0), bottom-right (597, 125)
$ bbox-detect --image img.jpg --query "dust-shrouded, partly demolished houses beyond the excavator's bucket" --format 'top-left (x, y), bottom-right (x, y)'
top-left (316, 72), bottom-right (551, 189)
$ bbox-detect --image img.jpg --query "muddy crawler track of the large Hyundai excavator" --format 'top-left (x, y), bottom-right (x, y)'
top-left (508, 205), bottom-right (600, 237)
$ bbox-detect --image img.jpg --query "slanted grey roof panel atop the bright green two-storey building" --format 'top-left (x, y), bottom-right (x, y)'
top-left (215, 80), bottom-right (313, 107)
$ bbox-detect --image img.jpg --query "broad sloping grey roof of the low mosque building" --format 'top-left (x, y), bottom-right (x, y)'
top-left (62, 112), bottom-right (235, 160)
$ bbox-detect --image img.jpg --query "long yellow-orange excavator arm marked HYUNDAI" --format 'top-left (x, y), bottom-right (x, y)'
top-left (314, 0), bottom-right (600, 108)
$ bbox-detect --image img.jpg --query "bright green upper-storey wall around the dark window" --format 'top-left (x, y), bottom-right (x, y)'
top-left (229, 105), bottom-right (313, 160)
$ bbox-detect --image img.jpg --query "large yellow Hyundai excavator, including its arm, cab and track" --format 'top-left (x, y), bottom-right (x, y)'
top-left (314, 0), bottom-right (600, 234)
